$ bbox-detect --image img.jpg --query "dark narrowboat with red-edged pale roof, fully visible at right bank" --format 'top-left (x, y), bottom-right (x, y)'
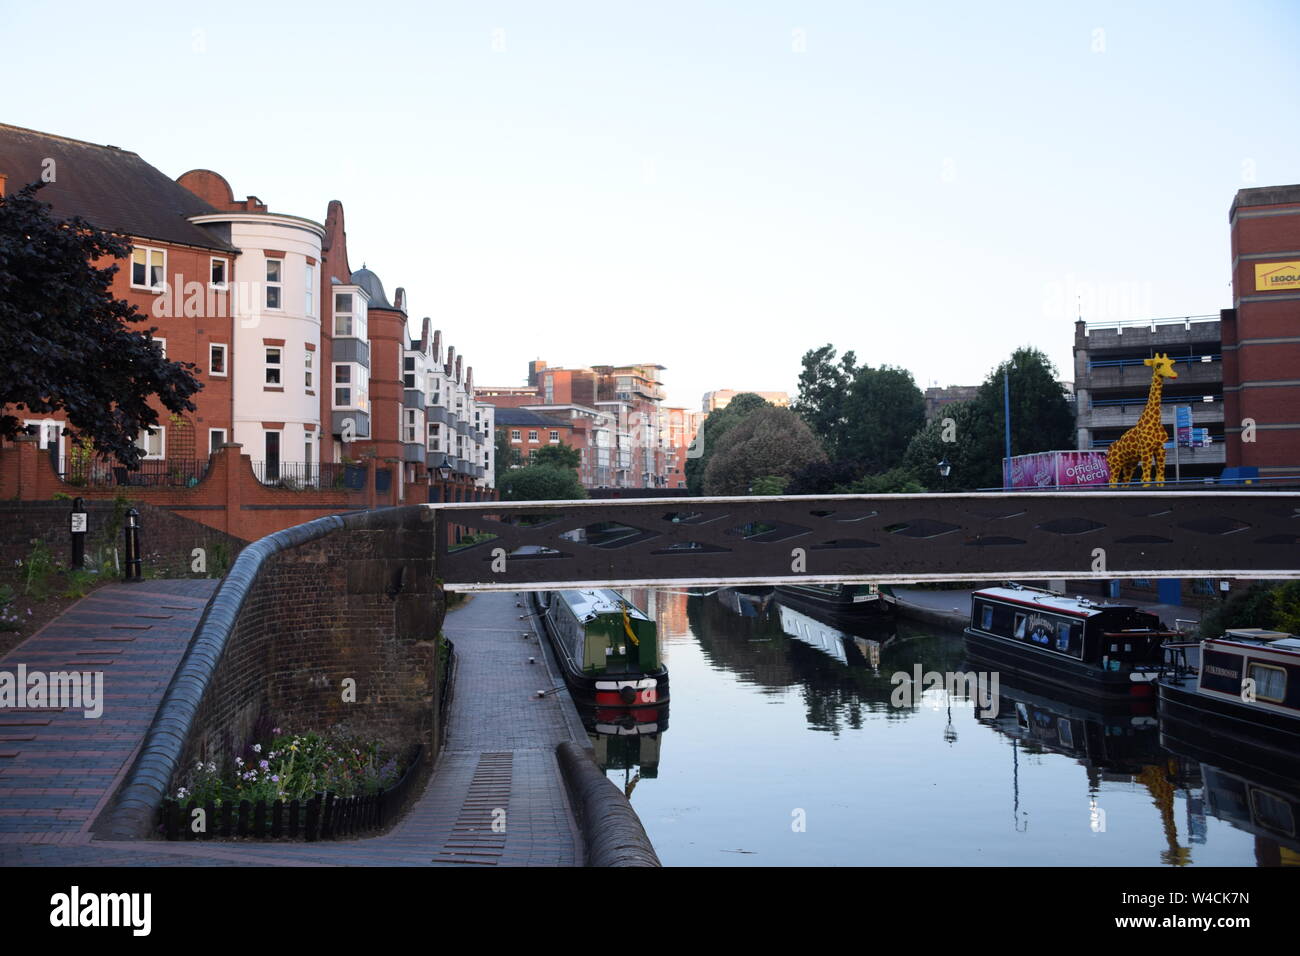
top-left (966, 584), bottom-right (1178, 697)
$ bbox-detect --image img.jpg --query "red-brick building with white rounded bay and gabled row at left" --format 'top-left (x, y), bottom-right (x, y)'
top-left (0, 120), bottom-right (495, 540)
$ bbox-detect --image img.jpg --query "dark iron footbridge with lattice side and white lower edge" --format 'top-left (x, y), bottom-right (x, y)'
top-left (434, 490), bottom-right (1300, 592)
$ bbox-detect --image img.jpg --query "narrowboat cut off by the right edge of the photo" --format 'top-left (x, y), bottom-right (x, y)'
top-left (1158, 627), bottom-right (1300, 774)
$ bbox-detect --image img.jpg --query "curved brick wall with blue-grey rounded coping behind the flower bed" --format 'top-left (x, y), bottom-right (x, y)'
top-left (95, 506), bottom-right (445, 839)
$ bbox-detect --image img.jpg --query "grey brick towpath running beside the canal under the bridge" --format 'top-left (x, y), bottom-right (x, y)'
top-left (0, 593), bottom-right (585, 866)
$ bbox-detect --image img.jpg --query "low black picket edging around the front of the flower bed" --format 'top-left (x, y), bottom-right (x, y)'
top-left (160, 747), bottom-right (424, 842)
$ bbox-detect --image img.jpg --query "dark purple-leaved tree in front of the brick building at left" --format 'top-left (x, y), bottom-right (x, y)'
top-left (0, 183), bottom-right (203, 467)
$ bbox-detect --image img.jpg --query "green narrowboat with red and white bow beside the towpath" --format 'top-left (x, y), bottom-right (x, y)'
top-left (540, 588), bottom-right (668, 708)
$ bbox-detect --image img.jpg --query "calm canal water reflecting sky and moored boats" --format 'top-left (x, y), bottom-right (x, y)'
top-left (588, 591), bottom-right (1300, 866)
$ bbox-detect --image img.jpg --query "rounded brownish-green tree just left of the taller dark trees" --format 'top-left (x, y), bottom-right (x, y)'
top-left (703, 402), bottom-right (826, 496)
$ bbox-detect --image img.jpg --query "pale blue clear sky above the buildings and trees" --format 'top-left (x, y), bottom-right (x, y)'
top-left (0, 0), bottom-right (1300, 407)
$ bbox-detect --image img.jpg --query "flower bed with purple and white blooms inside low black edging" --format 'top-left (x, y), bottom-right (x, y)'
top-left (161, 727), bottom-right (420, 840)
